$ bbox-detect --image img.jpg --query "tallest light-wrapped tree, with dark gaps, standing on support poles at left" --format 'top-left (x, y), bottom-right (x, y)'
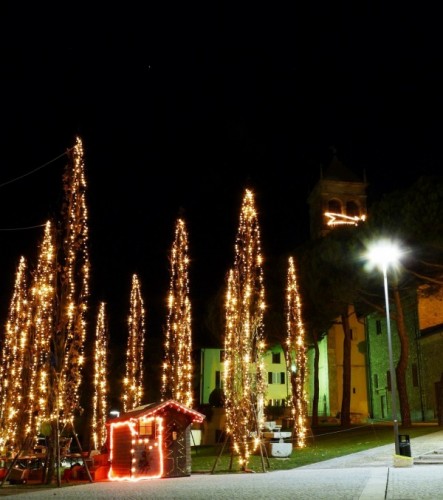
top-left (48, 137), bottom-right (92, 485)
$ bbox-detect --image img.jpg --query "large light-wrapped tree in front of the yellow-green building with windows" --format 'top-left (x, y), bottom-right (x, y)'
top-left (223, 190), bottom-right (266, 470)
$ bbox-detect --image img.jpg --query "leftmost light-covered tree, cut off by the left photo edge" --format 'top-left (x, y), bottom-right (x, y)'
top-left (0, 257), bottom-right (29, 456)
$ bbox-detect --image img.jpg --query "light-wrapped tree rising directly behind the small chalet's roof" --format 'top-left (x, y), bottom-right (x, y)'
top-left (161, 219), bottom-right (193, 408)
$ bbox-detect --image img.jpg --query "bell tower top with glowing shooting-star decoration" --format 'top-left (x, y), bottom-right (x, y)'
top-left (308, 151), bottom-right (367, 239)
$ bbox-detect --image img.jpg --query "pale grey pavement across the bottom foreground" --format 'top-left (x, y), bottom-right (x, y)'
top-left (0, 430), bottom-right (443, 500)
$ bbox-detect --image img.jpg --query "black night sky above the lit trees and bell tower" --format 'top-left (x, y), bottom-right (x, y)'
top-left (0, 1), bottom-right (443, 368)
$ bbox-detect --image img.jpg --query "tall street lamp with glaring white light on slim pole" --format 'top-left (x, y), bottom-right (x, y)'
top-left (367, 240), bottom-right (401, 455)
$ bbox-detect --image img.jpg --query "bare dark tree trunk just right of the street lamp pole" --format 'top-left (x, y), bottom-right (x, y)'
top-left (393, 286), bottom-right (412, 427)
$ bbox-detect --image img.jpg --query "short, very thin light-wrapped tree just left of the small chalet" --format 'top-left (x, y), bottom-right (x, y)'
top-left (92, 302), bottom-right (109, 450)
